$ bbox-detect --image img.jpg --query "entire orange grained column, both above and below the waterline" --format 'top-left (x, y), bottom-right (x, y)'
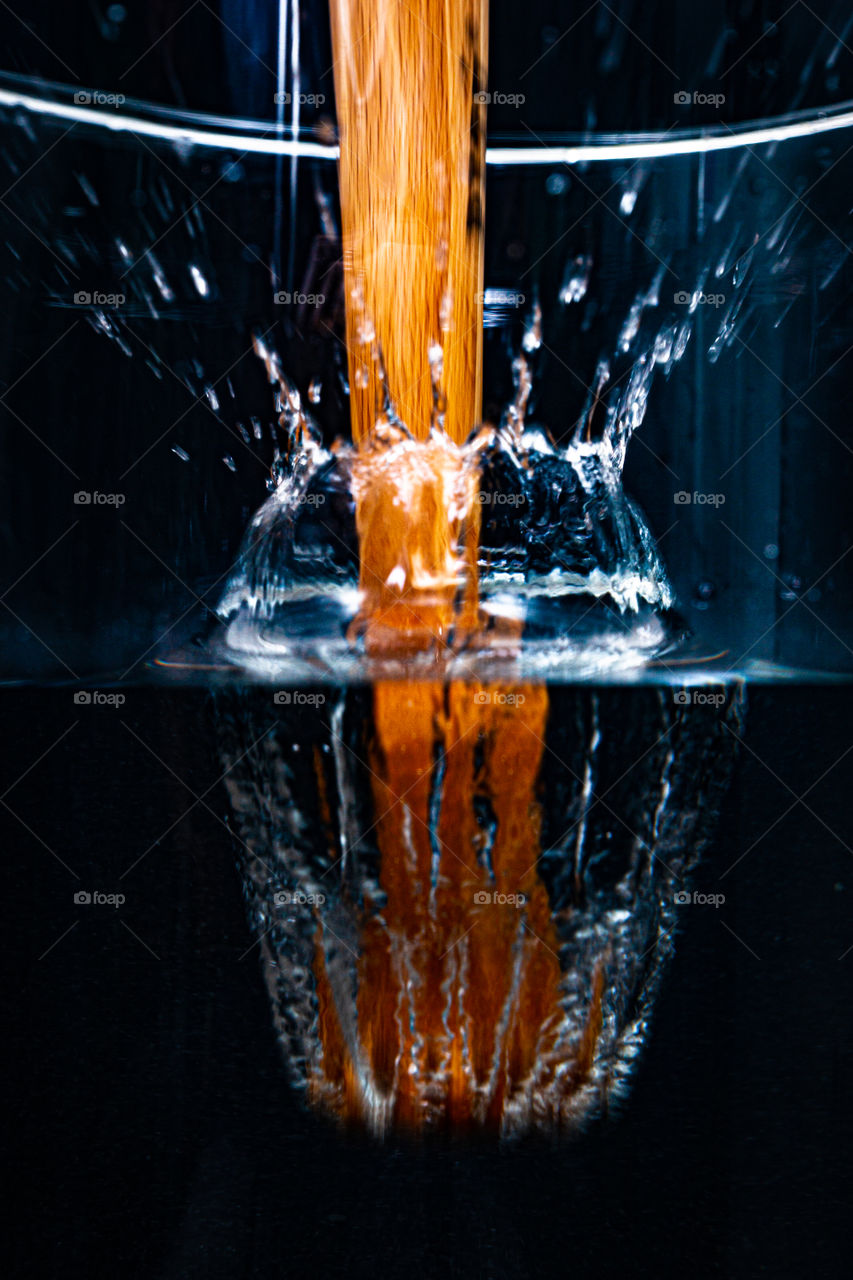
top-left (310, 0), bottom-right (601, 1129)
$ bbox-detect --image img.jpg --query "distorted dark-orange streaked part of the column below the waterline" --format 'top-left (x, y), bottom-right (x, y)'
top-left (311, 682), bottom-right (601, 1129)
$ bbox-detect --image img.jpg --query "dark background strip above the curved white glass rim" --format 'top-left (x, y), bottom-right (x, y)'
top-left (0, 0), bottom-right (853, 133)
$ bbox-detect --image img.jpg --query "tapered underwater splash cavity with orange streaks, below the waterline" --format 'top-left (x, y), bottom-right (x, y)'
top-left (219, 682), bottom-right (740, 1134)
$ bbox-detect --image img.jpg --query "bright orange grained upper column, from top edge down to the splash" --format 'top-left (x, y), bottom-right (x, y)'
top-left (330, 0), bottom-right (488, 442)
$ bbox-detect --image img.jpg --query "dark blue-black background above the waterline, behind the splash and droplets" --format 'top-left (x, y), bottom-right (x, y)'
top-left (0, 0), bottom-right (853, 680)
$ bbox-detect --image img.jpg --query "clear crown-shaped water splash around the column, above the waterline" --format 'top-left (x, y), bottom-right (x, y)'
top-left (218, 317), bottom-right (686, 669)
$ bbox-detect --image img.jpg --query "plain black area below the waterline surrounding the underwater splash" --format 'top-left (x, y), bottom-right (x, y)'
top-left (0, 686), bottom-right (853, 1280)
